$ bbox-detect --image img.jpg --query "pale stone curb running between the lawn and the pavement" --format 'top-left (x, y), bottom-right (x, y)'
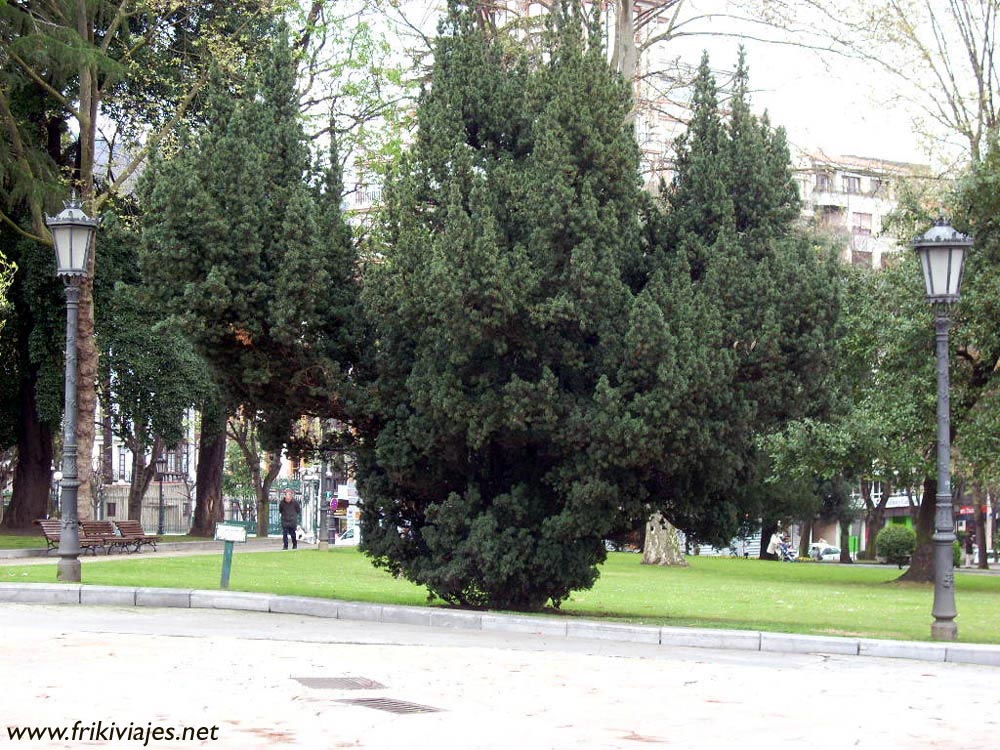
top-left (0, 582), bottom-right (1000, 667)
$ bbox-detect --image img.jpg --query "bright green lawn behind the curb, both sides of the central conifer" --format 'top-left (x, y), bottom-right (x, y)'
top-left (0, 546), bottom-right (1000, 643)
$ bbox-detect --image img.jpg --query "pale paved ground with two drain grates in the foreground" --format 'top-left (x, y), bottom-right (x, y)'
top-left (0, 604), bottom-right (1000, 750)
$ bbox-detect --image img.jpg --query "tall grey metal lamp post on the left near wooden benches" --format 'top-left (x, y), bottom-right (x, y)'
top-left (45, 195), bottom-right (99, 583)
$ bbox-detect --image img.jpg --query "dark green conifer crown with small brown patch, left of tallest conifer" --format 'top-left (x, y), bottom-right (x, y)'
top-left (143, 29), bottom-right (355, 449)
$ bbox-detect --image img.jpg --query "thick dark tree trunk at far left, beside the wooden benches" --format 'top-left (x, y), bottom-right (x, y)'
top-left (3, 372), bottom-right (52, 529)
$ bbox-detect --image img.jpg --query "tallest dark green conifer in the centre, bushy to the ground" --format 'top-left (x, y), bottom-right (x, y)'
top-left (359, 1), bottom-right (639, 608)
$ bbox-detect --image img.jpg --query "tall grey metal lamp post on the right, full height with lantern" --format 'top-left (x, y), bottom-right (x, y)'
top-left (913, 219), bottom-right (972, 641)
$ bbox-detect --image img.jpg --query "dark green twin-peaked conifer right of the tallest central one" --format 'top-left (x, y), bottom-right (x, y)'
top-left (648, 54), bottom-right (840, 542)
